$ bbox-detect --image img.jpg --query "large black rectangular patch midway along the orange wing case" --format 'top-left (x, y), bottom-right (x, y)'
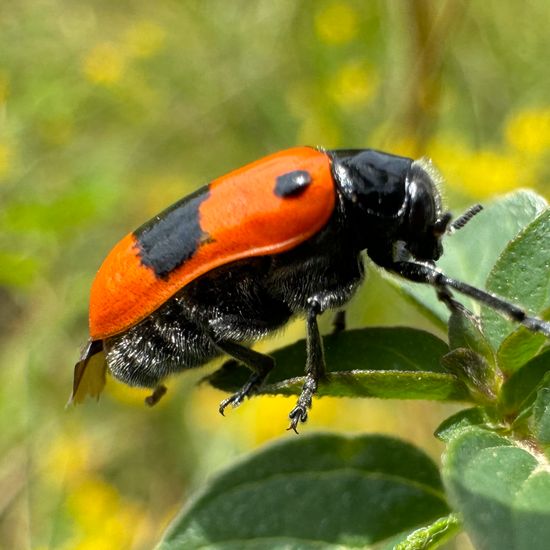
top-left (134, 186), bottom-right (211, 279)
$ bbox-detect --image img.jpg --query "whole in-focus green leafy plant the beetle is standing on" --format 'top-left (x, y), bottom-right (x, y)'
top-left (159, 191), bottom-right (550, 550)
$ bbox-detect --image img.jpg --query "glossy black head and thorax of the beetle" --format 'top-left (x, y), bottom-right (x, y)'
top-left (331, 149), bottom-right (451, 261)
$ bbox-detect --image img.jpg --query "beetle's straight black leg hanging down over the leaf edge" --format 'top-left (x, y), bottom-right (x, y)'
top-left (288, 297), bottom-right (326, 433)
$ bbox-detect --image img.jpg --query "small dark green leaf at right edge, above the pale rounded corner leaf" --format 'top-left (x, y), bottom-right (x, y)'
top-left (500, 349), bottom-right (550, 414)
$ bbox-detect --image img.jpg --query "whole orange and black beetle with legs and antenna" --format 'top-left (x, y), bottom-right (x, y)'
top-left (71, 147), bottom-right (550, 431)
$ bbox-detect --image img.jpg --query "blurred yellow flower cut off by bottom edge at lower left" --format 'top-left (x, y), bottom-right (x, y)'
top-left (67, 478), bottom-right (146, 550)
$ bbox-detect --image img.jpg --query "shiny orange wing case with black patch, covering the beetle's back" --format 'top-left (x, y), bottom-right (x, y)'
top-left (89, 147), bottom-right (336, 340)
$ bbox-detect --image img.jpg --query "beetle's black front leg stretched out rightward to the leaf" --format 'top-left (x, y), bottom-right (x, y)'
top-left (388, 262), bottom-right (550, 338)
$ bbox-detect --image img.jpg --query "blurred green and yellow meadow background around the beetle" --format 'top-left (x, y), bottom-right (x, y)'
top-left (0, 0), bottom-right (550, 550)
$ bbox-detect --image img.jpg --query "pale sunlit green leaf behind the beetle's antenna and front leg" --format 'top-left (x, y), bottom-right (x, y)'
top-left (388, 191), bottom-right (547, 323)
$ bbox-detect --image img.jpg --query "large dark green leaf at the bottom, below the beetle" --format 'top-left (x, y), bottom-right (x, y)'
top-left (159, 434), bottom-right (449, 550)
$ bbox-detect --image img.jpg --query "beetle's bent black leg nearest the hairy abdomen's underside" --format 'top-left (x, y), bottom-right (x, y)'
top-left (216, 341), bottom-right (275, 415)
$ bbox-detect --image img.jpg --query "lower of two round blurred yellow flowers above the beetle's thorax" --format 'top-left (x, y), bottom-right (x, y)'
top-left (329, 61), bottom-right (379, 108)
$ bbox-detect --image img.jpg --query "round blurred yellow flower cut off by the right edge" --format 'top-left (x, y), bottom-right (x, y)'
top-left (504, 108), bottom-right (550, 156)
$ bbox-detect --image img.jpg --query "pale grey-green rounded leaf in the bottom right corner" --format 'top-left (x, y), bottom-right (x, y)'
top-left (443, 427), bottom-right (550, 550)
